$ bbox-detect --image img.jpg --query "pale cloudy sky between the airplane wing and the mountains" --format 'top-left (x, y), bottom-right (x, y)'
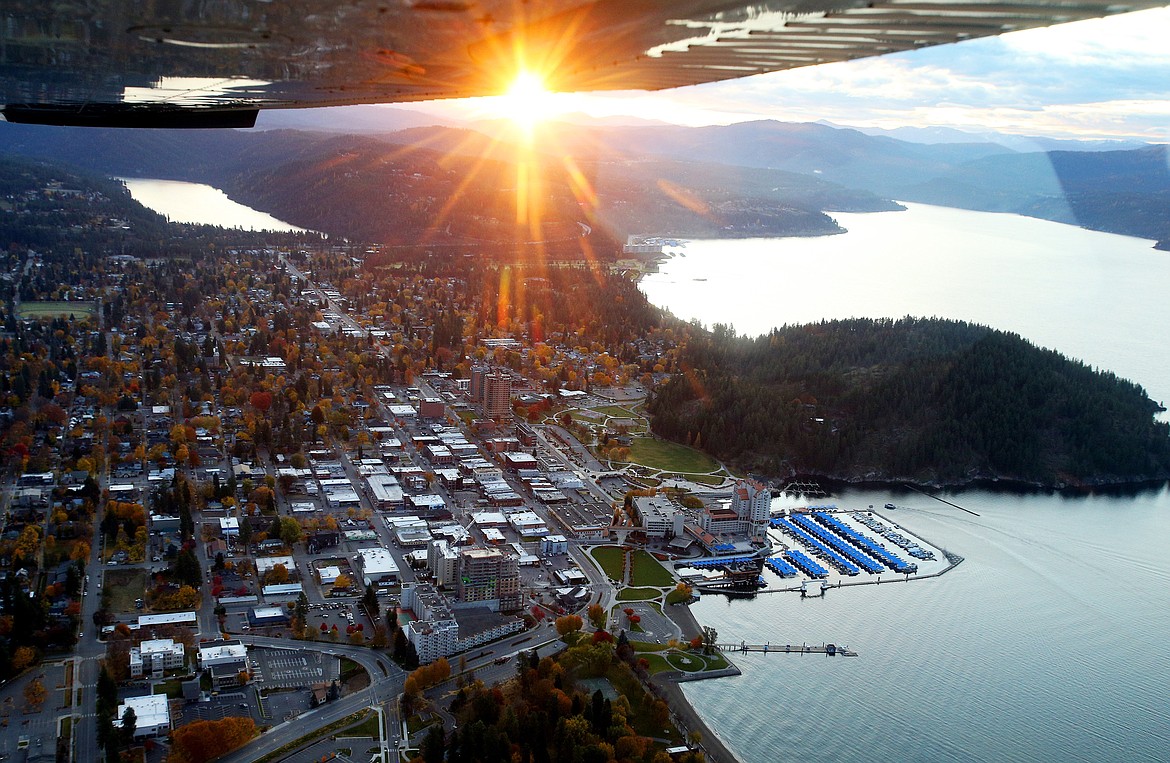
top-left (399, 7), bottom-right (1170, 143)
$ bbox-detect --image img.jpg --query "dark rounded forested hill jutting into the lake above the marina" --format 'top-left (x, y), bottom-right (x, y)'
top-left (651, 318), bottom-right (1170, 487)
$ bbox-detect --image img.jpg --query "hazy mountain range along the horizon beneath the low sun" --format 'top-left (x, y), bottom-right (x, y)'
top-left (0, 116), bottom-right (1170, 248)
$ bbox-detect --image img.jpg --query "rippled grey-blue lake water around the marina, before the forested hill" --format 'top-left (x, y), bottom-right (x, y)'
top-left (683, 488), bottom-right (1170, 763)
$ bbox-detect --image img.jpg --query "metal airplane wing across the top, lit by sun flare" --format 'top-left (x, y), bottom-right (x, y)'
top-left (0, 0), bottom-right (1166, 128)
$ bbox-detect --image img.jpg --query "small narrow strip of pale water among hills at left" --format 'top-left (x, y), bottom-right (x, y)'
top-left (119, 178), bottom-right (315, 233)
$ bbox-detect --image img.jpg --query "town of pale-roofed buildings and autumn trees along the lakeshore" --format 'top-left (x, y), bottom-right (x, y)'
top-left (0, 163), bottom-right (932, 763)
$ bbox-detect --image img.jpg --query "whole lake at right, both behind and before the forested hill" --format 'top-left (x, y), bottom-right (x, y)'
top-left (642, 205), bottom-right (1170, 763)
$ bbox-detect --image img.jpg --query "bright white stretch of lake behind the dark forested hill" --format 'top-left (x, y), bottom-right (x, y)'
top-left (641, 204), bottom-right (1170, 404)
